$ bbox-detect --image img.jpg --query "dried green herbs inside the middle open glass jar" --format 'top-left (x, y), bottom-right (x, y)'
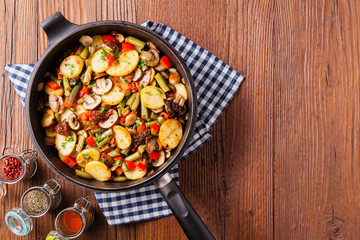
top-left (23, 189), bottom-right (49, 214)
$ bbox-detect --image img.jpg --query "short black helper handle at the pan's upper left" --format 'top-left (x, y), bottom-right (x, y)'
top-left (40, 12), bottom-right (78, 48)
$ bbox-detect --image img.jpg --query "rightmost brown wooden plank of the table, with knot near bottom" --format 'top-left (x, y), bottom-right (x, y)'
top-left (274, 1), bottom-right (360, 239)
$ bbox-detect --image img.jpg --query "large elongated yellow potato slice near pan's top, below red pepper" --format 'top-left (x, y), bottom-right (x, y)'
top-left (106, 50), bottom-right (139, 77)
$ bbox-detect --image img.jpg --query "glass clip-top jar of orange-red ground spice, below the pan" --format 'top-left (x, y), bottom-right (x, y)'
top-left (55, 196), bottom-right (94, 239)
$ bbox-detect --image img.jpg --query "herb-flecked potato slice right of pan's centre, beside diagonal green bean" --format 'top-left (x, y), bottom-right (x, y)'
top-left (141, 86), bottom-right (166, 109)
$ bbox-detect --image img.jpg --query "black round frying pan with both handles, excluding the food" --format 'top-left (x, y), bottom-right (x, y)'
top-left (25, 12), bottom-right (214, 239)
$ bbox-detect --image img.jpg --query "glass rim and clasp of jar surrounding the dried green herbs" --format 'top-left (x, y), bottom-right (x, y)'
top-left (21, 179), bottom-right (62, 217)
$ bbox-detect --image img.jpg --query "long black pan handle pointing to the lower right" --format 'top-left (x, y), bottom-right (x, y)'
top-left (155, 173), bottom-right (215, 240)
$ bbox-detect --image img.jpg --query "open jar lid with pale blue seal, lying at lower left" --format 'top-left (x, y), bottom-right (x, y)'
top-left (5, 207), bottom-right (34, 236)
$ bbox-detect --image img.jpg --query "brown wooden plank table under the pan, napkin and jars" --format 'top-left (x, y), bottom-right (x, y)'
top-left (0, 0), bottom-right (360, 240)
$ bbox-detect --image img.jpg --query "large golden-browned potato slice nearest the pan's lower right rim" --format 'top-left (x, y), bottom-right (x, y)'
top-left (159, 119), bottom-right (182, 149)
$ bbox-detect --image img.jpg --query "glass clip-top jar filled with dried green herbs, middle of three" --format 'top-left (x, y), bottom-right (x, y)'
top-left (21, 179), bottom-right (62, 217)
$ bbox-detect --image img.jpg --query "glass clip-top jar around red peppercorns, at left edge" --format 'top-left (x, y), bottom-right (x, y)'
top-left (0, 149), bottom-right (38, 184)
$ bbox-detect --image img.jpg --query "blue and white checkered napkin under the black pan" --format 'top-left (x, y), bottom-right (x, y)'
top-left (5, 21), bottom-right (243, 225)
